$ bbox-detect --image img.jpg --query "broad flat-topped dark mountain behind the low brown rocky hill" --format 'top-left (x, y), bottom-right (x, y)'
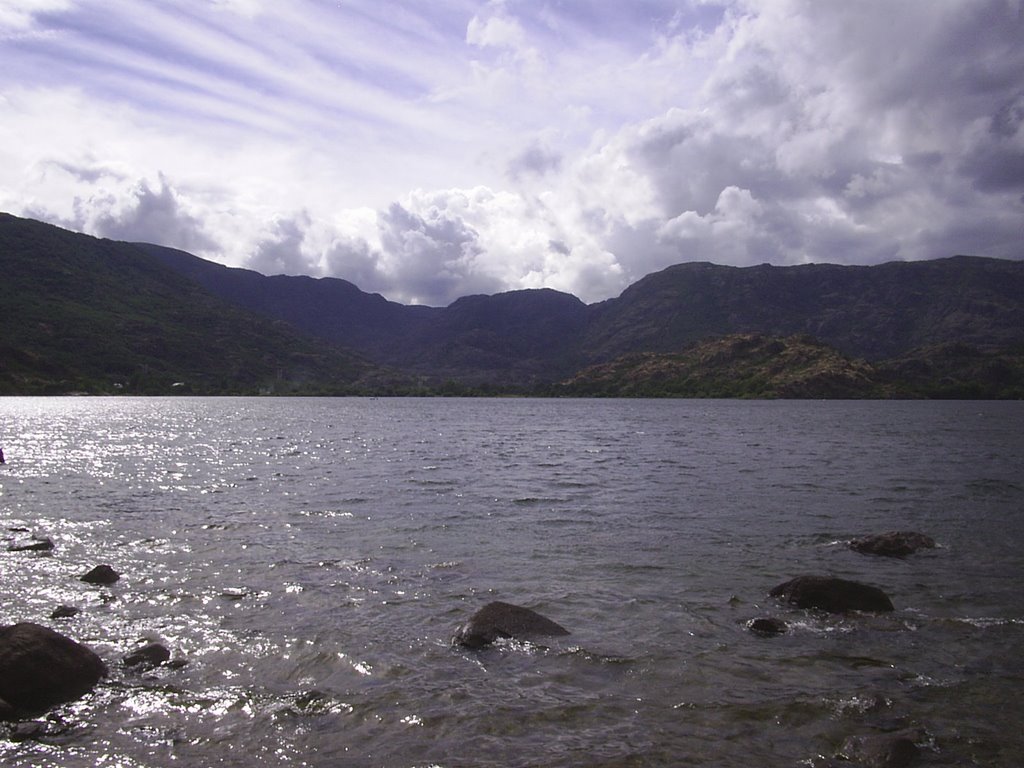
top-left (583, 256), bottom-right (1024, 361)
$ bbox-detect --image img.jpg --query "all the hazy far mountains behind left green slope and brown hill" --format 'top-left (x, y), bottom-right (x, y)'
top-left (138, 239), bottom-right (1024, 385)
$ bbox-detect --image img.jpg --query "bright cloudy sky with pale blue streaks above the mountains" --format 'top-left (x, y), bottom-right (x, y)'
top-left (0, 0), bottom-right (1024, 306)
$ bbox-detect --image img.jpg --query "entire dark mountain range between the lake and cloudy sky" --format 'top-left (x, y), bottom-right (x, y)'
top-left (0, 214), bottom-right (1024, 396)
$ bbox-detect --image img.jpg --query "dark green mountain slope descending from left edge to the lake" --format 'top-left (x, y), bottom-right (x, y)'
top-left (0, 214), bottom-right (374, 393)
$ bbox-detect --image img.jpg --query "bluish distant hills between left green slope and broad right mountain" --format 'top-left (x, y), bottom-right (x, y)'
top-left (138, 244), bottom-right (587, 386)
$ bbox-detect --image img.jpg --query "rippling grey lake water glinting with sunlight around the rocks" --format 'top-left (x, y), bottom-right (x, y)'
top-left (0, 397), bottom-right (1024, 768)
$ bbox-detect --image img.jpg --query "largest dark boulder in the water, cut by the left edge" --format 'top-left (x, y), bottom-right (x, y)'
top-left (0, 623), bottom-right (106, 717)
